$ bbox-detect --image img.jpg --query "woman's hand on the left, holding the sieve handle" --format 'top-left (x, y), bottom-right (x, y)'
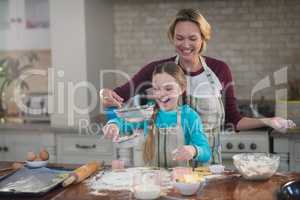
top-left (100, 88), bottom-right (124, 108)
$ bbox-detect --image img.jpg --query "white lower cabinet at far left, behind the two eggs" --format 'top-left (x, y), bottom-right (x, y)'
top-left (0, 131), bottom-right (56, 162)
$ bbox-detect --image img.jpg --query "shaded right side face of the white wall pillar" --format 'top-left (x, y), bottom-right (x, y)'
top-left (85, 0), bottom-right (115, 117)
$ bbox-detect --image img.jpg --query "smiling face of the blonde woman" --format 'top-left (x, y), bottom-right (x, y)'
top-left (174, 21), bottom-right (202, 62)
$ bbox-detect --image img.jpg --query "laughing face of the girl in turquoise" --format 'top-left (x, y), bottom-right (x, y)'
top-left (152, 73), bottom-right (183, 111)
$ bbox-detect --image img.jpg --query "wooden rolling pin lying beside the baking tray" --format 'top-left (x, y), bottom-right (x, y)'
top-left (63, 161), bottom-right (103, 187)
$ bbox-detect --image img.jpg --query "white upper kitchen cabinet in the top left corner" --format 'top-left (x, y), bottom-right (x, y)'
top-left (0, 0), bottom-right (50, 50)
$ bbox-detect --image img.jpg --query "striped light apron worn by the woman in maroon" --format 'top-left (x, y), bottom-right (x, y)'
top-left (175, 56), bottom-right (225, 164)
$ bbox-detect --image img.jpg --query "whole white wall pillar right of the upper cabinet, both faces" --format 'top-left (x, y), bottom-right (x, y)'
top-left (50, 0), bottom-right (114, 127)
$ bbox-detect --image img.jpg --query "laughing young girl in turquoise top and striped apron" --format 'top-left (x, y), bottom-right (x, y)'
top-left (103, 62), bottom-right (211, 167)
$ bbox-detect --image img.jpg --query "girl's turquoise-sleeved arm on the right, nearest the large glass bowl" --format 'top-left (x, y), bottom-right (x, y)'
top-left (184, 108), bottom-right (211, 162)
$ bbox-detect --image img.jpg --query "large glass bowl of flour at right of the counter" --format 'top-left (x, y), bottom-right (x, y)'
top-left (232, 153), bottom-right (280, 180)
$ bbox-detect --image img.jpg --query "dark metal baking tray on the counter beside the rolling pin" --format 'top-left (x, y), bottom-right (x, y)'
top-left (0, 167), bottom-right (71, 196)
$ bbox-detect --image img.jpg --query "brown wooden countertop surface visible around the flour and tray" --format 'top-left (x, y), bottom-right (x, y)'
top-left (0, 162), bottom-right (300, 200)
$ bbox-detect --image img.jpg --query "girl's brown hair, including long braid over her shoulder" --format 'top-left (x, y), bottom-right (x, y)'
top-left (143, 62), bottom-right (187, 164)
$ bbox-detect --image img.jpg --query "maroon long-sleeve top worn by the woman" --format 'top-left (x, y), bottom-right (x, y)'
top-left (114, 56), bottom-right (242, 128)
